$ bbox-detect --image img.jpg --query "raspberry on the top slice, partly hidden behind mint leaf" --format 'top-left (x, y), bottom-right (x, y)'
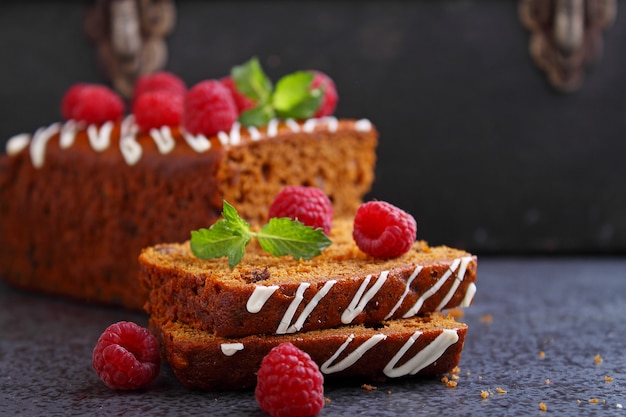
top-left (268, 185), bottom-right (333, 234)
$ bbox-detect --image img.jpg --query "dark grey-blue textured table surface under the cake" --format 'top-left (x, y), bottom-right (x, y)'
top-left (0, 258), bottom-right (626, 417)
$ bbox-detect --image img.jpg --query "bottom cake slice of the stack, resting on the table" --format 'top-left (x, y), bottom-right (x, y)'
top-left (150, 313), bottom-right (467, 390)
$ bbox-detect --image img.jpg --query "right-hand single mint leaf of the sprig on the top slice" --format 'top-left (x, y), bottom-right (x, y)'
top-left (256, 217), bottom-right (331, 259)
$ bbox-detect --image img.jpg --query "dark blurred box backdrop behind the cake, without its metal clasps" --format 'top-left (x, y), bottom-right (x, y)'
top-left (0, 0), bottom-right (626, 254)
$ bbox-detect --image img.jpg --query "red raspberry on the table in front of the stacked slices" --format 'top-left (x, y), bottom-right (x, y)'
top-left (254, 343), bottom-right (325, 417)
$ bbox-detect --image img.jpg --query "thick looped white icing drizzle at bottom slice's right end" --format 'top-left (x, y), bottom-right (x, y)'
top-left (383, 329), bottom-right (459, 378)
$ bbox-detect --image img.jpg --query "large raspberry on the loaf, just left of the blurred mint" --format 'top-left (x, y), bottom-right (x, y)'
top-left (183, 80), bottom-right (239, 136)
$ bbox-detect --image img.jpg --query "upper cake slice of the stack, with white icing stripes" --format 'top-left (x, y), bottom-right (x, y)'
top-left (139, 219), bottom-right (477, 337)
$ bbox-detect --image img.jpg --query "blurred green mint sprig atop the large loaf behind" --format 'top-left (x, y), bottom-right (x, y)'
top-left (231, 58), bottom-right (324, 127)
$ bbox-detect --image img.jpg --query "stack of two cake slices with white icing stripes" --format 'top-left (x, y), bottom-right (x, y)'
top-left (139, 219), bottom-right (477, 390)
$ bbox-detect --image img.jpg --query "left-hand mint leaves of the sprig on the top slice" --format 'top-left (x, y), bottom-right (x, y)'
top-left (190, 201), bottom-right (253, 268)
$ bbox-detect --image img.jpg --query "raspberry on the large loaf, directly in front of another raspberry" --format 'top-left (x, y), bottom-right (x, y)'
top-left (133, 91), bottom-right (183, 132)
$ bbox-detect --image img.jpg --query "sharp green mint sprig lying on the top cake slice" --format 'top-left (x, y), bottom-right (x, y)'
top-left (190, 201), bottom-right (332, 269)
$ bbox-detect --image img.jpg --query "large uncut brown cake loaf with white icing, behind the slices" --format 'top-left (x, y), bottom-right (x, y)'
top-left (0, 116), bottom-right (378, 310)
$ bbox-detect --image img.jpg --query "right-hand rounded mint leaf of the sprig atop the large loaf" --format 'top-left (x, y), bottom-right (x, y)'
top-left (272, 71), bottom-right (324, 119)
